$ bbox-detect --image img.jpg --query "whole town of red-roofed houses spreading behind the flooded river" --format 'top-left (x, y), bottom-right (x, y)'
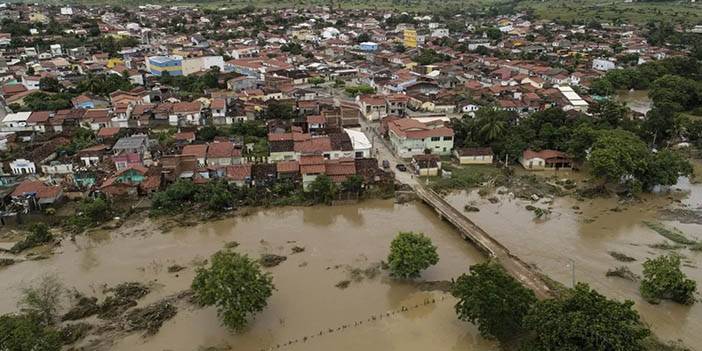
top-left (0, 3), bottom-right (678, 217)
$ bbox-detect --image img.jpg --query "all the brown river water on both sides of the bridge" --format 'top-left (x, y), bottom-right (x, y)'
top-left (0, 167), bottom-right (702, 351)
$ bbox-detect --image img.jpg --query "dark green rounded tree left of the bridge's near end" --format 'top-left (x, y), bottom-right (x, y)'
top-left (451, 262), bottom-right (536, 340)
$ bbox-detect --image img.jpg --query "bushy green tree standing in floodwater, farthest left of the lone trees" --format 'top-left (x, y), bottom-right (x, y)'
top-left (192, 251), bottom-right (275, 331)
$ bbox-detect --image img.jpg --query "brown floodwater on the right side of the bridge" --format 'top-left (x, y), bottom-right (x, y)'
top-left (447, 172), bottom-right (702, 350)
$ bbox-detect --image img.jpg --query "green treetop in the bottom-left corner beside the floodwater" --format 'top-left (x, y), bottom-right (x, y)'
top-left (0, 314), bottom-right (61, 351)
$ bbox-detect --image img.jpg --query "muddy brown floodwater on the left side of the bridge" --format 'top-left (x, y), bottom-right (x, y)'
top-left (0, 200), bottom-right (497, 351)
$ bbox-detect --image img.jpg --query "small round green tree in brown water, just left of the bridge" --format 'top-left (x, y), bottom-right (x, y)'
top-left (388, 232), bottom-right (439, 279)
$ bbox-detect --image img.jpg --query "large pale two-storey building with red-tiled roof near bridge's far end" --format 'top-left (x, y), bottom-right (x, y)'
top-left (387, 118), bottom-right (453, 158)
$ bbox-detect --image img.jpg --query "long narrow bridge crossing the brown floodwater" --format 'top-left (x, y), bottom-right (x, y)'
top-left (414, 184), bottom-right (555, 299)
